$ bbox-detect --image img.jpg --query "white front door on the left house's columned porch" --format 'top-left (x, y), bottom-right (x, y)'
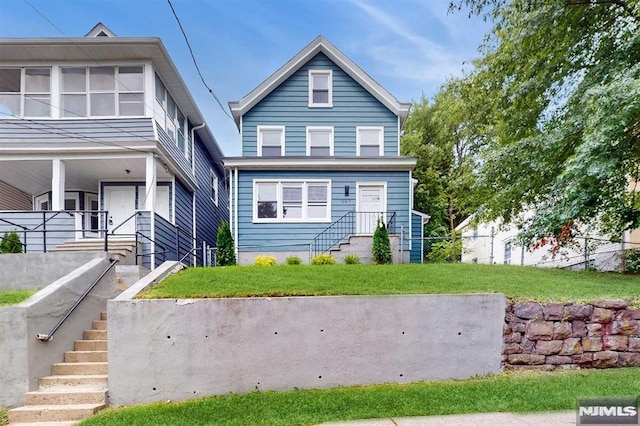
top-left (104, 186), bottom-right (136, 235)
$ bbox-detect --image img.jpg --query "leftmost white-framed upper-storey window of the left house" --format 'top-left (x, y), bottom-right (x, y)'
top-left (0, 68), bottom-right (51, 117)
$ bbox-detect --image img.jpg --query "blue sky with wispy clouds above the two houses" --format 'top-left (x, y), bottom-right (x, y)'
top-left (0, 0), bottom-right (490, 156)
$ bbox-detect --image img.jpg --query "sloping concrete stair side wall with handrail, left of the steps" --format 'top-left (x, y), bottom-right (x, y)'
top-left (0, 255), bottom-right (118, 407)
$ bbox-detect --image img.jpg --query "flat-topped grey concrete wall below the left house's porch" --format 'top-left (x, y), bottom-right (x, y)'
top-left (0, 253), bottom-right (105, 290)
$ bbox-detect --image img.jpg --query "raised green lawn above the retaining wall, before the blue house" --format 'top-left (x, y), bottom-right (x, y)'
top-left (139, 264), bottom-right (640, 303)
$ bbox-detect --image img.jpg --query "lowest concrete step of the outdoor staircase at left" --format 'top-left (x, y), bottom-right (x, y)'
top-left (8, 404), bottom-right (105, 423)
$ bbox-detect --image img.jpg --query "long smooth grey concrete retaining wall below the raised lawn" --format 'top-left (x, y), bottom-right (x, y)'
top-left (108, 289), bottom-right (506, 405)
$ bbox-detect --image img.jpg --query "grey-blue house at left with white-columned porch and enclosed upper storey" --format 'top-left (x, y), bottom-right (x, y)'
top-left (0, 24), bottom-right (228, 267)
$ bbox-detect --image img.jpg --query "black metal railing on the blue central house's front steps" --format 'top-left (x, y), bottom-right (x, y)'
top-left (311, 211), bottom-right (396, 255)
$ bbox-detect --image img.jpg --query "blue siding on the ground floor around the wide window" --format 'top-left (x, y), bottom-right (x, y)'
top-left (237, 171), bottom-right (410, 251)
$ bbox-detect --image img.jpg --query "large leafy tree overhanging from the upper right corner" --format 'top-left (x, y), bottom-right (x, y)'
top-left (458, 0), bottom-right (640, 242)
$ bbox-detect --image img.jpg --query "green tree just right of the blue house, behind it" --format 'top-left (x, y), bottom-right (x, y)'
top-left (401, 80), bottom-right (479, 236)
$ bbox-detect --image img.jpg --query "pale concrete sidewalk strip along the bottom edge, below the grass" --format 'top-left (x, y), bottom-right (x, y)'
top-left (322, 411), bottom-right (577, 426)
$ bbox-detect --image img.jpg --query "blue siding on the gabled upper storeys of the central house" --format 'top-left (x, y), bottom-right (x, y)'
top-left (242, 54), bottom-right (398, 157)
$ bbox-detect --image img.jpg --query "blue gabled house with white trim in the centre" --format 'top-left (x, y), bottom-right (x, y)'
top-left (224, 36), bottom-right (422, 263)
